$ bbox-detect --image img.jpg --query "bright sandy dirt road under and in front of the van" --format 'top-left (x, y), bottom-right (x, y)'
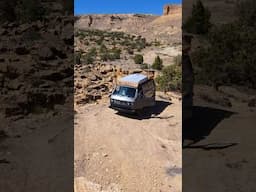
top-left (75, 92), bottom-right (182, 192)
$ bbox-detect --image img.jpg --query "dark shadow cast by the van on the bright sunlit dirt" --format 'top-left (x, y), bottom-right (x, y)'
top-left (116, 100), bottom-right (173, 120)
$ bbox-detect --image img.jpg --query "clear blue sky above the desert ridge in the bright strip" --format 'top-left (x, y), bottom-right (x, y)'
top-left (75, 0), bottom-right (181, 15)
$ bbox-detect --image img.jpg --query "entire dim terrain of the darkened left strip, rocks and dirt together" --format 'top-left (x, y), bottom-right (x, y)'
top-left (0, 1), bottom-right (74, 192)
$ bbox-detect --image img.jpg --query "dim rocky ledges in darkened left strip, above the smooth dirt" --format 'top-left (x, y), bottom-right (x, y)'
top-left (0, 12), bottom-right (74, 117)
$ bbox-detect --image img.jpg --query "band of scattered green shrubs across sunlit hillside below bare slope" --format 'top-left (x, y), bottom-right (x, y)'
top-left (75, 29), bottom-right (149, 64)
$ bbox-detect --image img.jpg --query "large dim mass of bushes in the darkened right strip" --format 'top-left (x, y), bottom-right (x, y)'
top-left (191, 0), bottom-right (256, 89)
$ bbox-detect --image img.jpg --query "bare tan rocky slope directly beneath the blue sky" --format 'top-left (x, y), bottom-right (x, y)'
top-left (75, 5), bottom-right (182, 44)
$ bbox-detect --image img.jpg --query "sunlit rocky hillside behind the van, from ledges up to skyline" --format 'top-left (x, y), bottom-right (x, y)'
top-left (75, 5), bottom-right (181, 104)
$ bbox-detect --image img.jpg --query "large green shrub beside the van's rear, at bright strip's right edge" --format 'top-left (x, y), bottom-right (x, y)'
top-left (156, 64), bottom-right (182, 91)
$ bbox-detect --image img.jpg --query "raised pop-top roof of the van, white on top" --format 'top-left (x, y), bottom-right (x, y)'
top-left (119, 73), bottom-right (148, 87)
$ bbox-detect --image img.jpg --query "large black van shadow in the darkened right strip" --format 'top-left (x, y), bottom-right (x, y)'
top-left (182, 106), bottom-right (235, 146)
